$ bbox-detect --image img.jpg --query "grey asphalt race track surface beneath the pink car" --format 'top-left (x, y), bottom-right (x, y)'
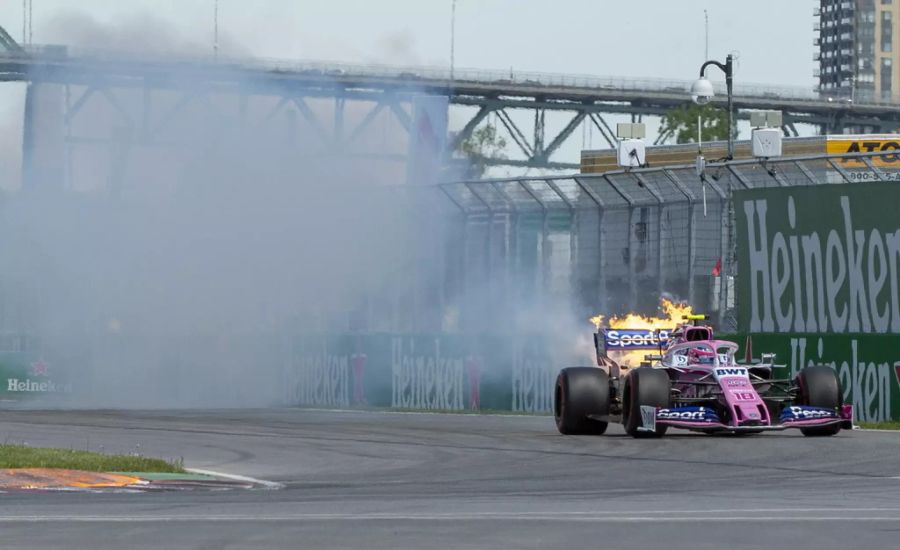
top-left (0, 409), bottom-right (900, 550)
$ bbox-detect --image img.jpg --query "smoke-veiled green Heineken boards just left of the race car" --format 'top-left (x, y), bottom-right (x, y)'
top-left (281, 333), bottom-right (587, 413)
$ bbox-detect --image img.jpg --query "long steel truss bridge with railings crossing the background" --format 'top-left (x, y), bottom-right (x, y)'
top-left (0, 35), bottom-right (900, 174)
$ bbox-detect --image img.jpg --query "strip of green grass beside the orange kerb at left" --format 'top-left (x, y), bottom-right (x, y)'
top-left (0, 445), bottom-right (184, 473)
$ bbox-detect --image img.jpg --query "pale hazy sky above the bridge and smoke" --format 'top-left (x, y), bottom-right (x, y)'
top-left (0, 0), bottom-right (817, 86)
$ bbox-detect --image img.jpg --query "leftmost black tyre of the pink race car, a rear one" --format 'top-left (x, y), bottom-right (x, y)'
top-left (553, 367), bottom-right (609, 435)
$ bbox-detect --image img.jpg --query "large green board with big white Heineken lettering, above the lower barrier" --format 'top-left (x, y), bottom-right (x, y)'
top-left (735, 182), bottom-right (900, 333)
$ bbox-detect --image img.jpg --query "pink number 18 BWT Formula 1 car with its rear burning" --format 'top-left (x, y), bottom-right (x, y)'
top-left (553, 315), bottom-right (853, 437)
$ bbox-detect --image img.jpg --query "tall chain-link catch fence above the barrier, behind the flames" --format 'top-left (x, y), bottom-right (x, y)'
top-left (415, 151), bottom-right (900, 331)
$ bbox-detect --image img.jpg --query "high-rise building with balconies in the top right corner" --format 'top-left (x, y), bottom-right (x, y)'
top-left (814, 0), bottom-right (900, 101)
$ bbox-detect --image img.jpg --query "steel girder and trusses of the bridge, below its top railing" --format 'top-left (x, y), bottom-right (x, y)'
top-left (7, 51), bottom-right (900, 175)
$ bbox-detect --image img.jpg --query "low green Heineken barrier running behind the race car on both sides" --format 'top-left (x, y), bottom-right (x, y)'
top-left (282, 333), bottom-right (900, 422)
